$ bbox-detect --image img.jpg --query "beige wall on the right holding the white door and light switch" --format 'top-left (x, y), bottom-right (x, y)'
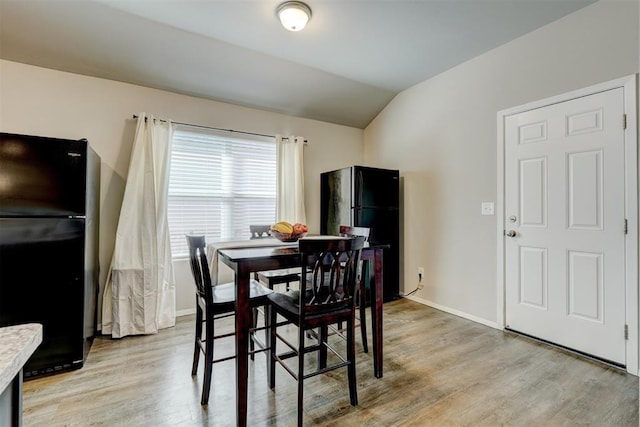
top-left (364, 0), bottom-right (639, 324)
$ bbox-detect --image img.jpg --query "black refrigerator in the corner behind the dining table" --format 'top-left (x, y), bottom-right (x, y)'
top-left (320, 166), bottom-right (400, 301)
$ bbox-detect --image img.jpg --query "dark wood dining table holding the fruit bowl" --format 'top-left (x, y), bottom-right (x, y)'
top-left (218, 242), bottom-right (385, 427)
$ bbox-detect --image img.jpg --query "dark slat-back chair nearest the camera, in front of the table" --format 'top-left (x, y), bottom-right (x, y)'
top-left (269, 237), bottom-right (364, 426)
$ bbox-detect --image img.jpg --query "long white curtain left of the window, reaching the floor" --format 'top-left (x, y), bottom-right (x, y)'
top-left (102, 113), bottom-right (176, 338)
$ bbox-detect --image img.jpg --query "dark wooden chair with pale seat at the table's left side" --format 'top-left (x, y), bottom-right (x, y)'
top-left (186, 236), bottom-right (273, 405)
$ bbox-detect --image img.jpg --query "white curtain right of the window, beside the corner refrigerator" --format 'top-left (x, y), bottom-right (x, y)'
top-left (276, 135), bottom-right (307, 224)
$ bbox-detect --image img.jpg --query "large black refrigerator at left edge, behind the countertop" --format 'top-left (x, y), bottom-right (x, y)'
top-left (0, 133), bottom-right (100, 379)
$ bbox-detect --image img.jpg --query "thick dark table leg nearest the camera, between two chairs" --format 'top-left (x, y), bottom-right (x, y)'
top-left (236, 268), bottom-right (251, 427)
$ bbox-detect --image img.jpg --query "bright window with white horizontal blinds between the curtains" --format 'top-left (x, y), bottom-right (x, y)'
top-left (168, 125), bottom-right (276, 257)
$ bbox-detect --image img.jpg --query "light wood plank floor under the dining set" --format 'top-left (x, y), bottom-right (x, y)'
top-left (24, 300), bottom-right (638, 427)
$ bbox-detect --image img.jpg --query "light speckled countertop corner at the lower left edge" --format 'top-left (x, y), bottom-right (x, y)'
top-left (0, 323), bottom-right (42, 392)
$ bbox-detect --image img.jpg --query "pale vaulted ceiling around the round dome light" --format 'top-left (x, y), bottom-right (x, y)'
top-left (0, 0), bottom-right (596, 128)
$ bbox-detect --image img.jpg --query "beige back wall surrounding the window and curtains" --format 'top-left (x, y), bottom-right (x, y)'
top-left (0, 61), bottom-right (363, 320)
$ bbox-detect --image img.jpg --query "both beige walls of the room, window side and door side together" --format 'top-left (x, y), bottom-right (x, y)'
top-left (0, 0), bottom-right (640, 332)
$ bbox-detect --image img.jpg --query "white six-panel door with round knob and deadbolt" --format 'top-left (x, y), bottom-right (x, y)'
top-left (504, 88), bottom-right (626, 365)
